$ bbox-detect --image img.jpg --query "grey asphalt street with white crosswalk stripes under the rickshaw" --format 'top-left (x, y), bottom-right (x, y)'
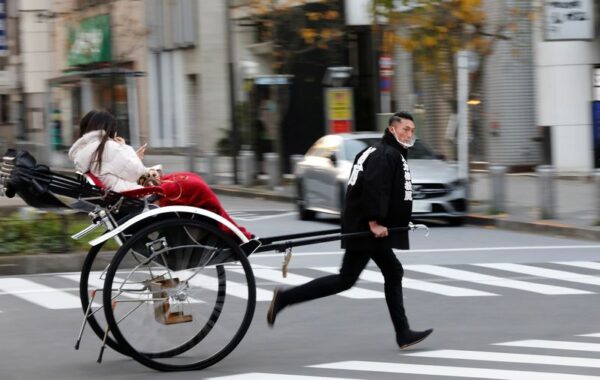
top-left (0, 196), bottom-right (600, 380)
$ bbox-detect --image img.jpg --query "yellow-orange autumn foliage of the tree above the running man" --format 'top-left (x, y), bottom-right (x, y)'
top-left (371, 0), bottom-right (532, 101)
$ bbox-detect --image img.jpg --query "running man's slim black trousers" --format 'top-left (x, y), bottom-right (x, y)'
top-left (280, 248), bottom-right (408, 333)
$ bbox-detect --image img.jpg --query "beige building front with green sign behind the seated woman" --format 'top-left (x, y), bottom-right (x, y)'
top-left (45, 0), bottom-right (148, 156)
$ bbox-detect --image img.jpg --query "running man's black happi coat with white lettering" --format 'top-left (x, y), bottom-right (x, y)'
top-left (342, 129), bottom-right (412, 250)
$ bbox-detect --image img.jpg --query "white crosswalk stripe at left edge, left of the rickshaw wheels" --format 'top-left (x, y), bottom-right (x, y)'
top-left (0, 278), bottom-right (81, 310)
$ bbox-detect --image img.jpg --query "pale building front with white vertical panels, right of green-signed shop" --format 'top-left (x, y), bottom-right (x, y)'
top-left (144, 0), bottom-right (231, 151)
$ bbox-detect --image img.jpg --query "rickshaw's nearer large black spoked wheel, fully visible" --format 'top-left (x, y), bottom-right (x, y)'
top-left (102, 219), bottom-right (256, 371)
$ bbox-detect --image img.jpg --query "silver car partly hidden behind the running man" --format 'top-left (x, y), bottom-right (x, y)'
top-left (295, 132), bottom-right (467, 225)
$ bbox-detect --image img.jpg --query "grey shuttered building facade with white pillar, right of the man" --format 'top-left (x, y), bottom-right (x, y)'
top-left (386, 0), bottom-right (600, 172)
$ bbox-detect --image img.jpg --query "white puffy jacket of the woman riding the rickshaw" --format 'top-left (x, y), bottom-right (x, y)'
top-left (69, 131), bottom-right (147, 192)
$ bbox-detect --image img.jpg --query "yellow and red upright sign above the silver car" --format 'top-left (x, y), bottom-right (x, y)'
top-left (325, 87), bottom-right (354, 133)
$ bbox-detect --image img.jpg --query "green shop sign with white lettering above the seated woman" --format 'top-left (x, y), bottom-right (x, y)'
top-left (67, 15), bottom-right (112, 66)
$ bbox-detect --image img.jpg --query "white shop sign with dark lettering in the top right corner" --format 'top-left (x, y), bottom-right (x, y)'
top-left (544, 0), bottom-right (595, 41)
